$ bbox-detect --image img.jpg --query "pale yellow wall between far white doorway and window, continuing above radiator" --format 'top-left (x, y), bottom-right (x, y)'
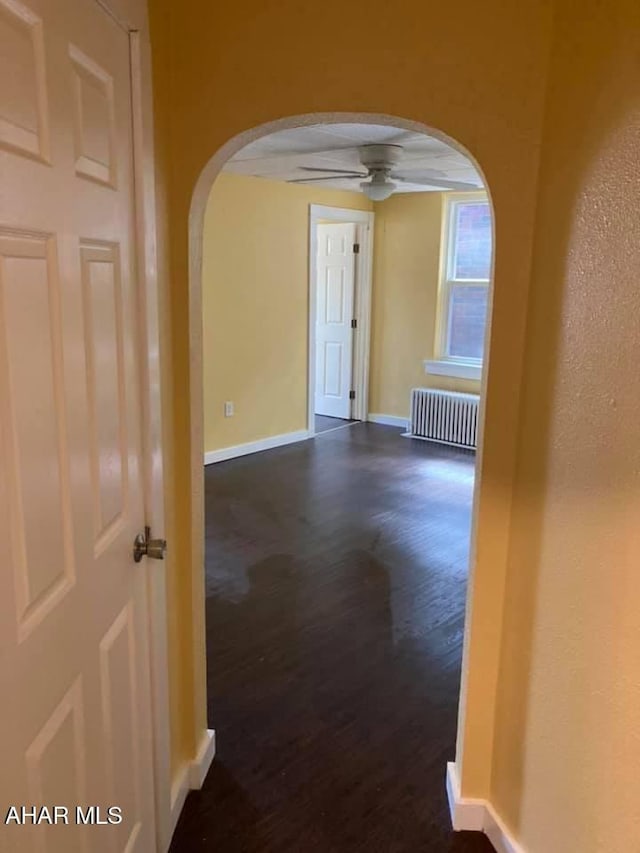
top-left (369, 193), bottom-right (480, 418)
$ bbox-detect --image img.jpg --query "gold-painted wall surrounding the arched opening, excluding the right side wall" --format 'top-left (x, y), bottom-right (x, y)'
top-left (150, 0), bottom-right (552, 796)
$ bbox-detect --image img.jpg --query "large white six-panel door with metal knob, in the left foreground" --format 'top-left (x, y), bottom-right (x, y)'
top-left (0, 0), bottom-right (155, 853)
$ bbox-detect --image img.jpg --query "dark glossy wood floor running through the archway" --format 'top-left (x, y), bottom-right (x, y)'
top-left (171, 424), bottom-right (492, 853)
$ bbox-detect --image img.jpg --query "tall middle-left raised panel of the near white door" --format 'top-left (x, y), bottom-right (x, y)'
top-left (0, 231), bottom-right (75, 636)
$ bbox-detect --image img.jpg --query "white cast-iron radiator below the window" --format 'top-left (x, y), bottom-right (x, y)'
top-left (406, 388), bottom-right (480, 448)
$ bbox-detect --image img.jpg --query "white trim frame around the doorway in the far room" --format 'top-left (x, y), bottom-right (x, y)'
top-left (307, 204), bottom-right (375, 437)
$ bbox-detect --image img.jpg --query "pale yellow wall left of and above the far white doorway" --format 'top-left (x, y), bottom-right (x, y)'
top-left (202, 173), bottom-right (373, 451)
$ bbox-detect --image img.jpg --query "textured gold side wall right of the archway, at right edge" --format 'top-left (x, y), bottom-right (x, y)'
top-left (492, 0), bottom-right (640, 853)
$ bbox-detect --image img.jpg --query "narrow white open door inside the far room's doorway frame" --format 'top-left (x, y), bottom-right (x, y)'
top-left (315, 222), bottom-right (356, 418)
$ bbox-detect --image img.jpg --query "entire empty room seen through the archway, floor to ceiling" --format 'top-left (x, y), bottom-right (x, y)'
top-left (182, 123), bottom-right (492, 851)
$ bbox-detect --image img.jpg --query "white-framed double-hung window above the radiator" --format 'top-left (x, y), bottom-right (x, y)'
top-left (439, 193), bottom-right (492, 368)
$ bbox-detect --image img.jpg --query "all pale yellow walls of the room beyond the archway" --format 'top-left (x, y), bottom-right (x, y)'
top-left (202, 173), bottom-right (472, 451)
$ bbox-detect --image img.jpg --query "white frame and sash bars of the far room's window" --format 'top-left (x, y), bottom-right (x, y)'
top-left (429, 190), bottom-right (493, 372)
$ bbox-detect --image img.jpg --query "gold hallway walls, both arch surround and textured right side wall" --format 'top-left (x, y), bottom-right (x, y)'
top-left (151, 0), bottom-right (640, 853)
